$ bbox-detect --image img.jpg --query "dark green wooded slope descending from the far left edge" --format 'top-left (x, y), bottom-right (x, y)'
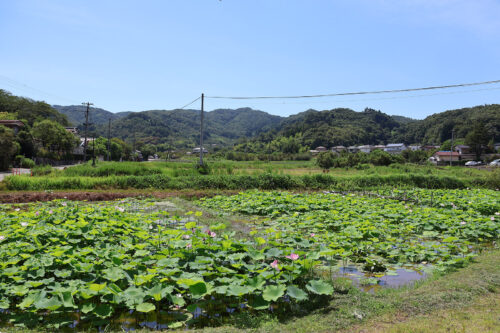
top-left (0, 89), bottom-right (69, 126)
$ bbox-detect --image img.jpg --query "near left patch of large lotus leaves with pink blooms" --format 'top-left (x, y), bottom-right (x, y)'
top-left (0, 201), bottom-right (333, 327)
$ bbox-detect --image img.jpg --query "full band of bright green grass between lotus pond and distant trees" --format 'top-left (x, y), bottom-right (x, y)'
top-left (4, 161), bottom-right (500, 191)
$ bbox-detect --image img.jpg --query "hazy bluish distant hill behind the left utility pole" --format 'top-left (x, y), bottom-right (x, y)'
top-left (52, 105), bottom-right (130, 126)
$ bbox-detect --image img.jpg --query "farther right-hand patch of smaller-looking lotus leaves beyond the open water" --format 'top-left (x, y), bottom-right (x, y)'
top-left (199, 189), bottom-right (500, 272)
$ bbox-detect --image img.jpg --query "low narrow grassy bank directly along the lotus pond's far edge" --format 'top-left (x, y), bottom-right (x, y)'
top-left (3, 173), bottom-right (498, 191)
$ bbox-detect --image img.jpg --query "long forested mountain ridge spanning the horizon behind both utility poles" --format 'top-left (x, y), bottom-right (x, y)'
top-left (54, 104), bottom-right (500, 147)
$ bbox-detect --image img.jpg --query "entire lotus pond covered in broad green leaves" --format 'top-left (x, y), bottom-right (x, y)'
top-left (0, 190), bottom-right (500, 329)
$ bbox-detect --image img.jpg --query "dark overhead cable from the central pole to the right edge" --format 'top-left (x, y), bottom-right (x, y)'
top-left (205, 80), bottom-right (500, 99)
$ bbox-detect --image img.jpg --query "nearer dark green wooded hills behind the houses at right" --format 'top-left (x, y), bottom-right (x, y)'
top-left (234, 104), bottom-right (500, 154)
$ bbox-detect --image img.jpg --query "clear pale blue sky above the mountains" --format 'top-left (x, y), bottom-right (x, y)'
top-left (0, 0), bottom-right (500, 118)
